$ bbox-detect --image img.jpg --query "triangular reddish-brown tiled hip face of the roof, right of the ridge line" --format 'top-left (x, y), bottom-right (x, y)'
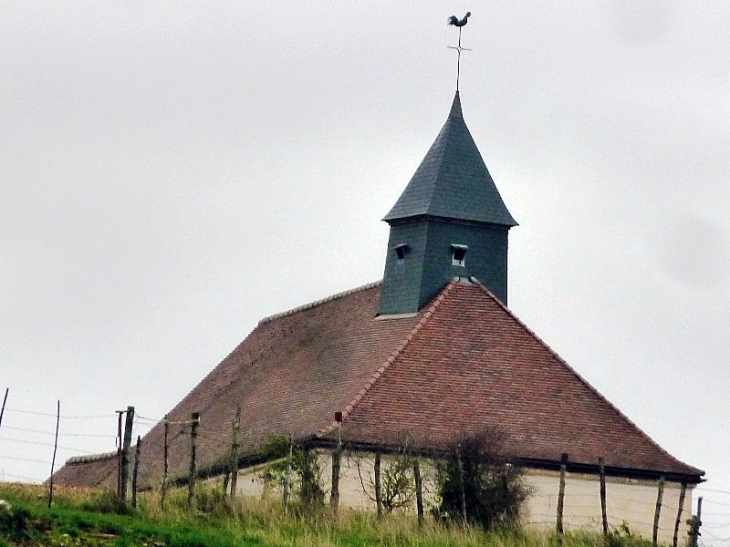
top-left (345, 282), bottom-right (701, 475)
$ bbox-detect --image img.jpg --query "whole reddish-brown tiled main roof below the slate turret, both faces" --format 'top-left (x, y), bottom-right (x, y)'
top-left (55, 281), bottom-right (702, 486)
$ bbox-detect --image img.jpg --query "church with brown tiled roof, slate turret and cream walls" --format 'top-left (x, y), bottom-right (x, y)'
top-left (54, 91), bottom-right (703, 541)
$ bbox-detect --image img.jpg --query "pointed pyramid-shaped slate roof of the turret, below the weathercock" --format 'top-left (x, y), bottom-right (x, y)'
top-left (383, 91), bottom-right (517, 226)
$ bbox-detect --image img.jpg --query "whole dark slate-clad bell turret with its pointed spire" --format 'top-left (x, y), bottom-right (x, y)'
top-left (380, 91), bottom-right (517, 315)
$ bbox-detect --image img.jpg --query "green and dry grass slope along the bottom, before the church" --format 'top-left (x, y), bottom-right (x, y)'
top-left (0, 484), bottom-right (645, 547)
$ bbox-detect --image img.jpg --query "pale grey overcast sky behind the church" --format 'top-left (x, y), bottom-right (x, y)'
top-left (0, 0), bottom-right (730, 545)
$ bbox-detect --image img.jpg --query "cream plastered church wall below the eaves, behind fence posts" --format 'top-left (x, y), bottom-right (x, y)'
top-left (230, 452), bottom-right (692, 545)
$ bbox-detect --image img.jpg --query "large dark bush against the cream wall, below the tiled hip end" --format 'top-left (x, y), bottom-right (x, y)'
top-left (434, 429), bottom-right (530, 530)
